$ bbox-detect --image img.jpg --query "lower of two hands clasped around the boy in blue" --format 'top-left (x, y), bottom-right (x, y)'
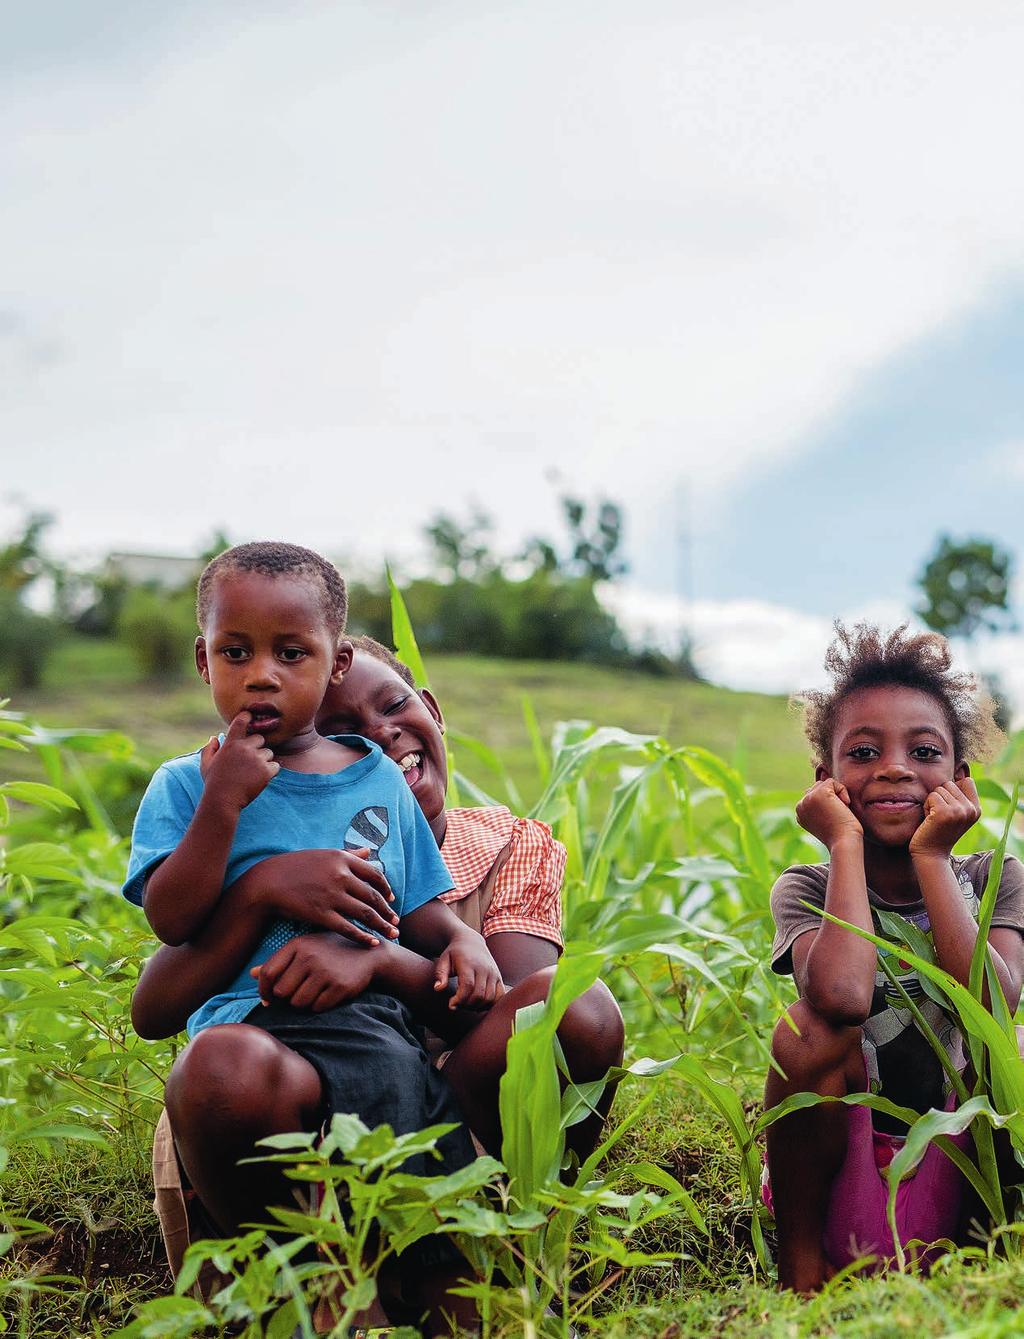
top-left (249, 935), bottom-right (381, 1014)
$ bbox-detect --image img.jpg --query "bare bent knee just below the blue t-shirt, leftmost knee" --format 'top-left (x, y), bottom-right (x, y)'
top-left (165, 1023), bottom-right (320, 1138)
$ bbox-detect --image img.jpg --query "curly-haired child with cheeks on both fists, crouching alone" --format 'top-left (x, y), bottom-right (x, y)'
top-left (764, 624), bottom-right (1024, 1292)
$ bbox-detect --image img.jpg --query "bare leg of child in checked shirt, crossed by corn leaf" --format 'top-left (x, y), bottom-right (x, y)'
top-left (444, 967), bottom-right (624, 1160)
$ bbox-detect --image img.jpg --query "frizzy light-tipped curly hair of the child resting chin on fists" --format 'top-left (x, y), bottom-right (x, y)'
top-left (795, 623), bottom-right (1003, 765)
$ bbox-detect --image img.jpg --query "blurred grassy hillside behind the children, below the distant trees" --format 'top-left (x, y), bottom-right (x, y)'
top-left (12, 637), bottom-right (810, 798)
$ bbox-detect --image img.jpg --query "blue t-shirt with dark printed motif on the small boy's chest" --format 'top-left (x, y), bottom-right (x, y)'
top-left (122, 735), bottom-right (451, 1036)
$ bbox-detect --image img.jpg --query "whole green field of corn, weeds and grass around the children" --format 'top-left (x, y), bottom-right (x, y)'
top-left (0, 640), bottom-right (1024, 1339)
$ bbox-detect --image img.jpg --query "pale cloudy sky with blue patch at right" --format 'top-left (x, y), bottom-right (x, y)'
top-left (0, 0), bottom-right (1024, 691)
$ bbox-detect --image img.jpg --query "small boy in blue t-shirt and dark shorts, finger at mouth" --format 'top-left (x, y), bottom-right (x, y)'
top-left (124, 544), bottom-right (501, 1328)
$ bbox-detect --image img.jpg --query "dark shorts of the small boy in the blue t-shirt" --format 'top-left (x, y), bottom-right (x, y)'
top-left (245, 991), bottom-right (477, 1264)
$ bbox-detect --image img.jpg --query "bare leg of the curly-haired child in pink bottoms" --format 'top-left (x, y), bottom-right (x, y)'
top-left (764, 1000), bottom-right (863, 1292)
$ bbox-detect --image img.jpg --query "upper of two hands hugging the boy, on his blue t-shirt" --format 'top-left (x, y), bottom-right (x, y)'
top-left (250, 846), bottom-right (399, 948)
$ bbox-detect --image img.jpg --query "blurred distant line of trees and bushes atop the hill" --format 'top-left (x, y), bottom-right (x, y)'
top-left (0, 497), bottom-right (697, 688)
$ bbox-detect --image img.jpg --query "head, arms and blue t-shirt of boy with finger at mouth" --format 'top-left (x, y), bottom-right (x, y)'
top-left (124, 544), bottom-right (501, 1035)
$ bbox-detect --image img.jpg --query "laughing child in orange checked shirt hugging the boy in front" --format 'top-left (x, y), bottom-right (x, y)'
top-left (133, 637), bottom-right (622, 1285)
